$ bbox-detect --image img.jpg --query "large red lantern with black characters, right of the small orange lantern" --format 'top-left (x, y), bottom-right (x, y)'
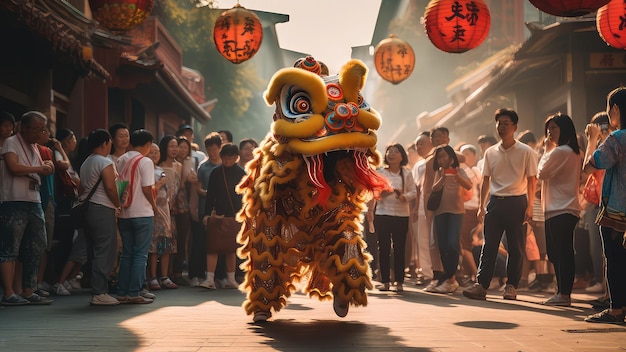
top-left (424, 0), bottom-right (491, 53)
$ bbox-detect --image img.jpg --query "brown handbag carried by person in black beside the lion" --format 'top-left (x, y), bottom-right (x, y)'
top-left (206, 167), bottom-right (241, 254)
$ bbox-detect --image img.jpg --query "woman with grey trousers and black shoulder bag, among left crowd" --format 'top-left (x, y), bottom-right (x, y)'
top-left (79, 129), bottom-right (120, 305)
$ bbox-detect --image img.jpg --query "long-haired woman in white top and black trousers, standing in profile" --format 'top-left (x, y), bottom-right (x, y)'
top-left (537, 113), bottom-right (582, 307)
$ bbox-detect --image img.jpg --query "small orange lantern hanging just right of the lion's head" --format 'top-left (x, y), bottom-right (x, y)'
top-left (374, 34), bottom-right (415, 84)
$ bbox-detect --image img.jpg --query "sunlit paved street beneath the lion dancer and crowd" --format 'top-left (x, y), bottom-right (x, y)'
top-left (0, 282), bottom-right (626, 352)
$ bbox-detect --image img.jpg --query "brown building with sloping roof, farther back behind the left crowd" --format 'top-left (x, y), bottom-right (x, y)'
top-left (82, 17), bottom-right (215, 139)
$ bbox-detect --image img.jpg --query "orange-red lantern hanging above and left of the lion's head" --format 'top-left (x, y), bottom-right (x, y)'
top-left (213, 3), bottom-right (263, 64)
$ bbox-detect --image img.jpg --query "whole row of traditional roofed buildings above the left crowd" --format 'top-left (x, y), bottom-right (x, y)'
top-left (0, 0), bottom-right (211, 138)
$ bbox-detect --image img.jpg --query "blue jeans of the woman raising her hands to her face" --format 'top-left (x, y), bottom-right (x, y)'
top-left (435, 213), bottom-right (465, 283)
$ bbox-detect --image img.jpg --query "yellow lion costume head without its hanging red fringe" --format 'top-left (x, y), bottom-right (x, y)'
top-left (265, 57), bottom-right (381, 155)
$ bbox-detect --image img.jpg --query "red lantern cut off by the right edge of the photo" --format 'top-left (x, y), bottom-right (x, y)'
top-left (596, 0), bottom-right (626, 49)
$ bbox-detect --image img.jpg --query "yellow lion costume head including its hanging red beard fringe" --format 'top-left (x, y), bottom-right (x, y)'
top-left (265, 56), bottom-right (383, 205)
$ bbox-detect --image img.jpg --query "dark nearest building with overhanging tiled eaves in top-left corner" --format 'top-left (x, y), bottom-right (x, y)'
top-left (0, 0), bottom-right (110, 135)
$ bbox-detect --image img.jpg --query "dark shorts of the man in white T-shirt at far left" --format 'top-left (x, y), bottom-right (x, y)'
top-left (0, 202), bottom-right (47, 262)
